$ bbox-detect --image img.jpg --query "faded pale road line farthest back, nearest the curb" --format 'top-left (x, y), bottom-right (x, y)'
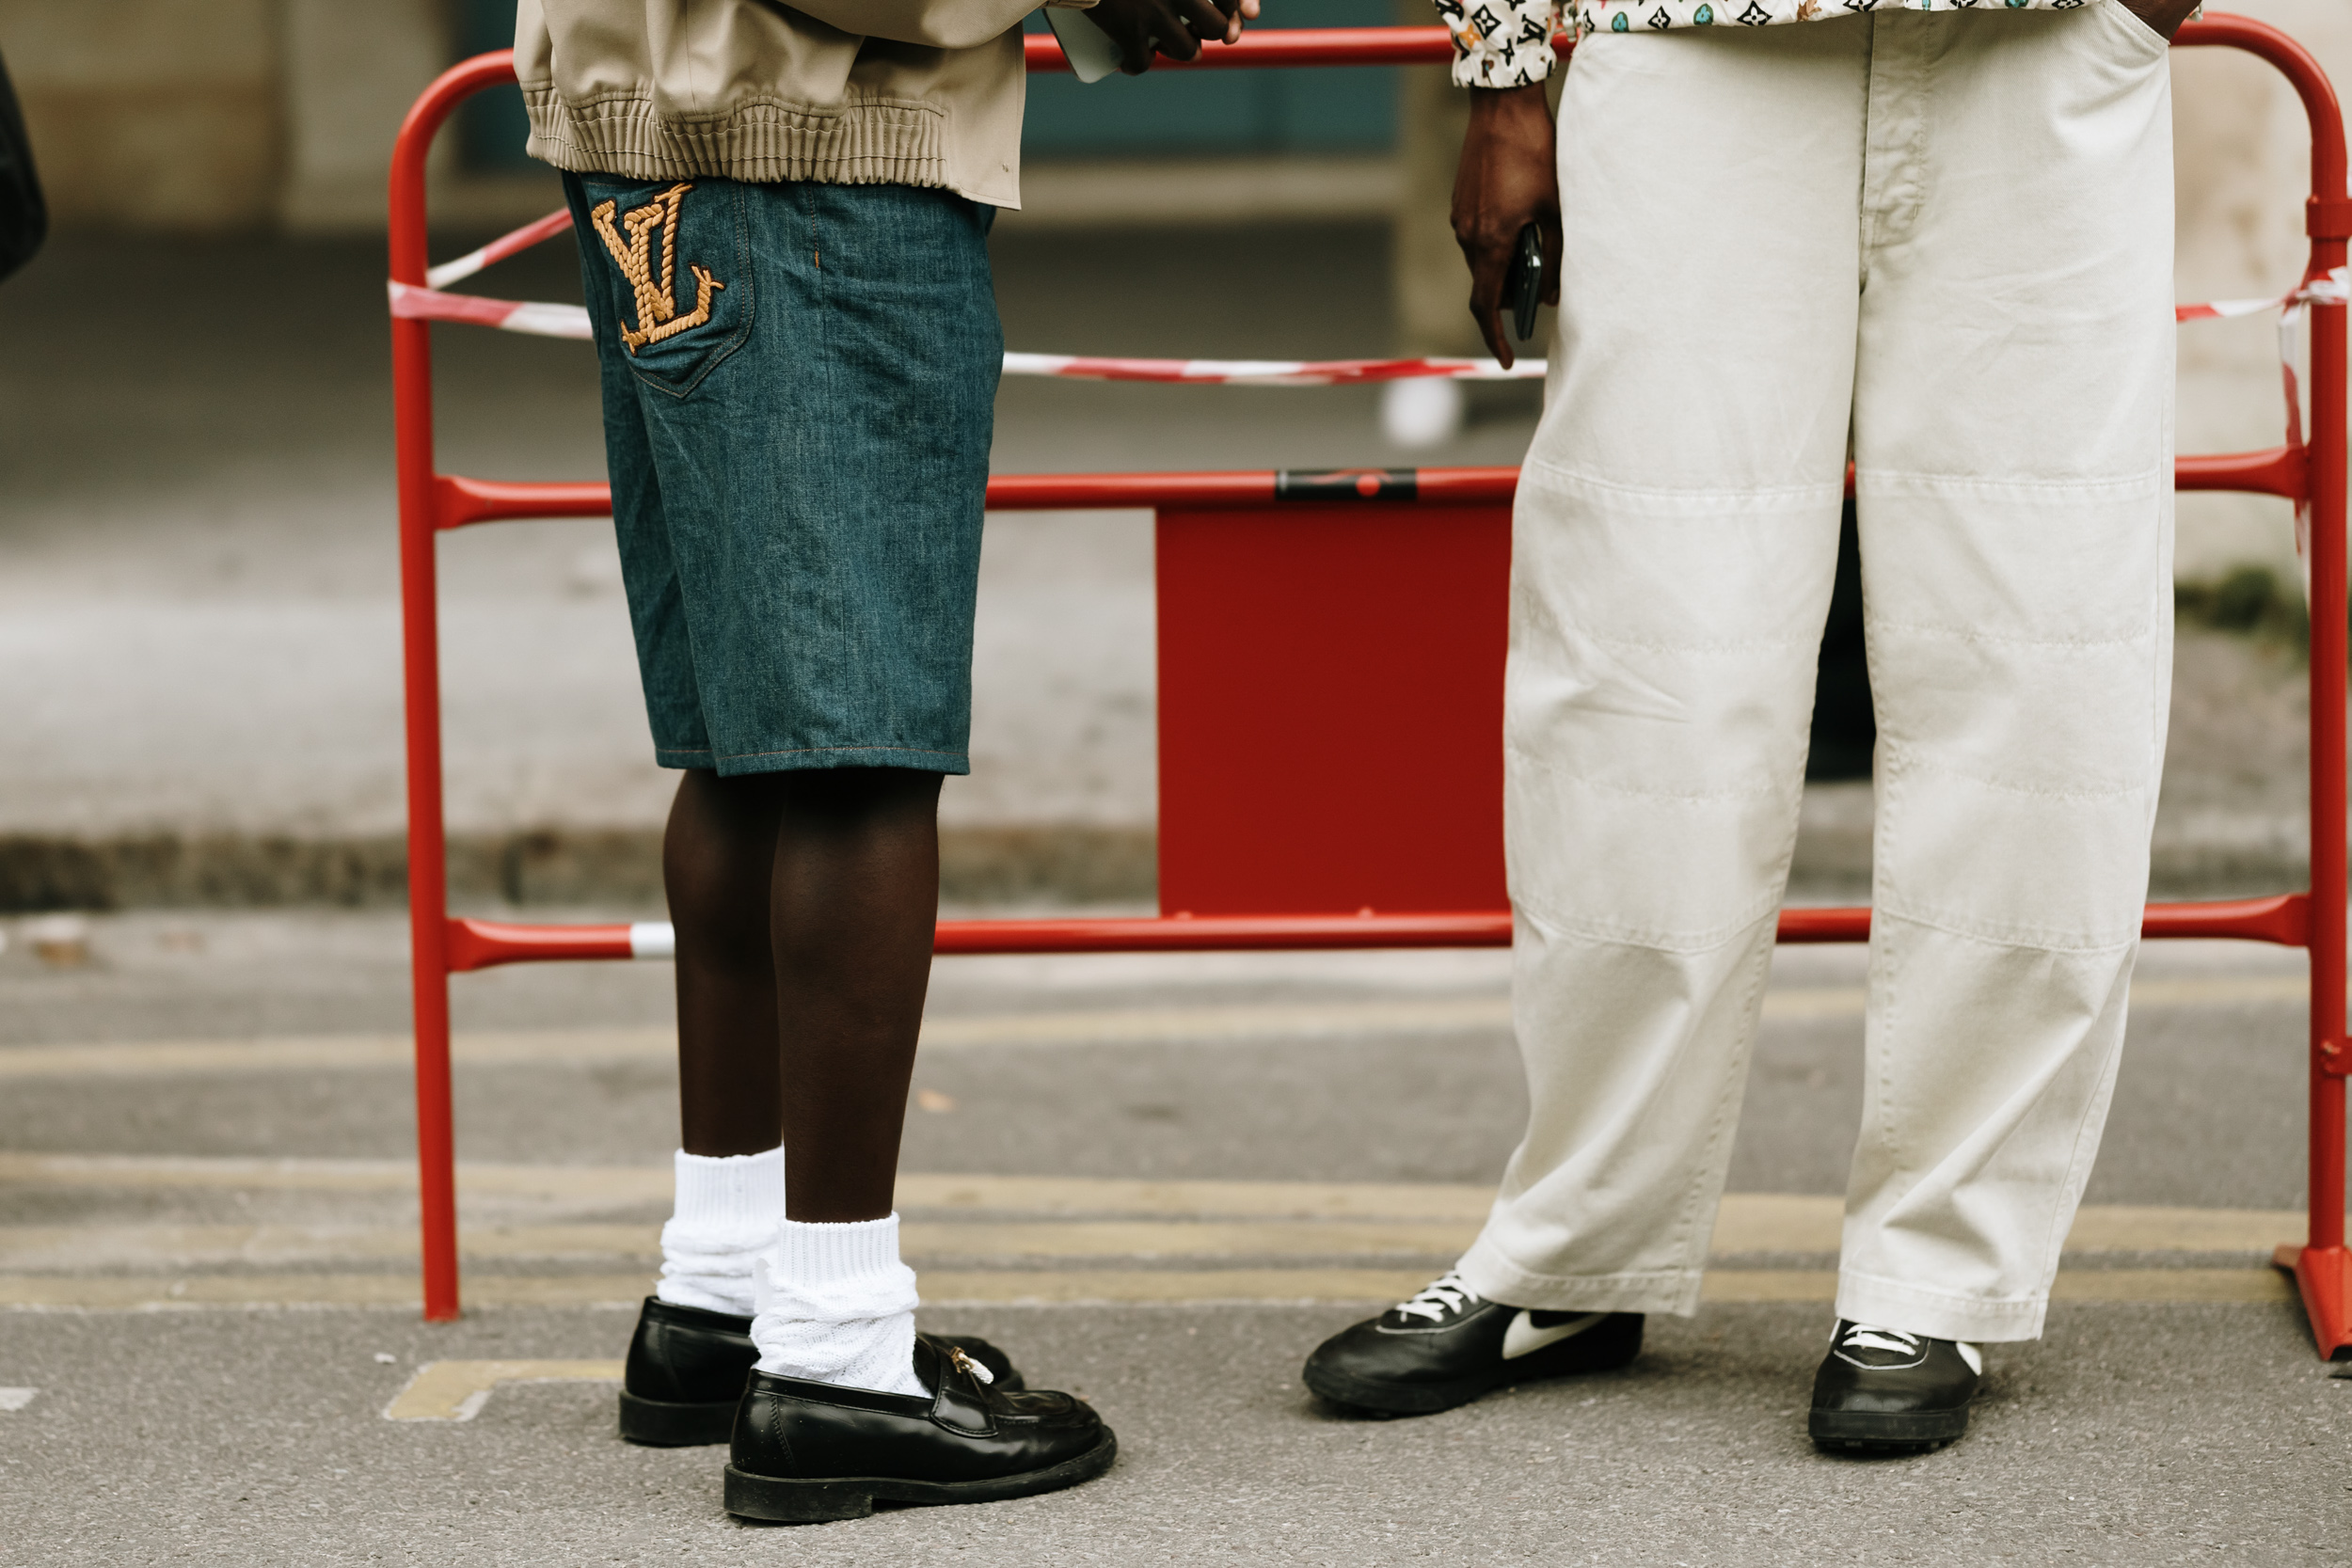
top-left (0, 975), bottom-right (2305, 1079)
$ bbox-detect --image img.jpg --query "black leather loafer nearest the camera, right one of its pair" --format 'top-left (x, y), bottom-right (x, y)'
top-left (727, 1336), bottom-right (1120, 1524)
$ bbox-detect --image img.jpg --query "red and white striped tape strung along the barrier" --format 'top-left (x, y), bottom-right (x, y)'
top-left (386, 212), bottom-right (2352, 386)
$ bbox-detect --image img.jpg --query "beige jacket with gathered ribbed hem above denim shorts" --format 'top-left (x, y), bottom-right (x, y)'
top-left (516, 0), bottom-right (1094, 207)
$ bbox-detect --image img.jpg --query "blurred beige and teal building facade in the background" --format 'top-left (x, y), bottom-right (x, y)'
top-left (0, 0), bottom-right (2352, 576)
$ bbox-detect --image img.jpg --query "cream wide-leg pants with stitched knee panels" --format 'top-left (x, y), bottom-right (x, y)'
top-left (1461, 0), bottom-right (2173, 1340)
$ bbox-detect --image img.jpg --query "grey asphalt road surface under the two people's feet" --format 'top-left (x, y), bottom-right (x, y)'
top-left (0, 912), bottom-right (2352, 1566)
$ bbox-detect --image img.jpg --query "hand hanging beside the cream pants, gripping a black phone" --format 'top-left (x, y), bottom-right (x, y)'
top-left (1454, 82), bottom-right (1560, 364)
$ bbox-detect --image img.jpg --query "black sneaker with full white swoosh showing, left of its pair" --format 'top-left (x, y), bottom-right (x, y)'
top-left (1306, 1275), bottom-right (1642, 1416)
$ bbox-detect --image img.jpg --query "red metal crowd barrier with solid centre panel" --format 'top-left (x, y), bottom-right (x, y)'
top-left (390, 16), bottom-right (2352, 1356)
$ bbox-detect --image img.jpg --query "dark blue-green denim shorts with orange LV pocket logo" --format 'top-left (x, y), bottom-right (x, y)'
top-left (564, 174), bottom-right (1005, 773)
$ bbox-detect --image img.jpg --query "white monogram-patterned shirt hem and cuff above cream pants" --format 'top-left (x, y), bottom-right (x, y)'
top-left (1438, 0), bottom-right (2089, 87)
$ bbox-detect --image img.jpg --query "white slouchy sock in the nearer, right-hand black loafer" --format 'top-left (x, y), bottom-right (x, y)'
top-left (751, 1215), bottom-right (930, 1394)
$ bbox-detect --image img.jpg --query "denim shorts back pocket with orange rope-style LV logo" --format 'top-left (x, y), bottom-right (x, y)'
top-left (581, 174), bottom-right (753, 397)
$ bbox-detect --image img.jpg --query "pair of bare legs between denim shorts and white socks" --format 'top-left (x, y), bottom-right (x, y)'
top-left (663, 768), bottom-right (939, 1223)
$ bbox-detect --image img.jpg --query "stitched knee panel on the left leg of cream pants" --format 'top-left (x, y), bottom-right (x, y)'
top-left (1503, 470), bottom-right (1837, 950)
